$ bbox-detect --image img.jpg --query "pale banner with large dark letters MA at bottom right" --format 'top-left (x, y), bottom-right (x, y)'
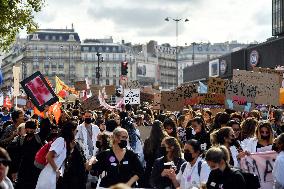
top-left (241, 151), bottom-right (277, 189)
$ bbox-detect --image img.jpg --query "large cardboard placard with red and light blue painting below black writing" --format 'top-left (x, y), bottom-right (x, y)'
top-left (225, 81), bottom-right (257, 112)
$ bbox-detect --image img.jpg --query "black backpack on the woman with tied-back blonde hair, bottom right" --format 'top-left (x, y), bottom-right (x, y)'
top-left (232, 168), bottom-right (260, 189)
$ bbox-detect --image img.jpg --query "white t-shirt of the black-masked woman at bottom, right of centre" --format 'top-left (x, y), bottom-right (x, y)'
top-left (176, 157), bottom-right (210, 189)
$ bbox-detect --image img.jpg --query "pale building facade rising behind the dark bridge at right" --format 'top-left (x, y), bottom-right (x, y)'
top-left (178, 41), bottom-right (247, 85)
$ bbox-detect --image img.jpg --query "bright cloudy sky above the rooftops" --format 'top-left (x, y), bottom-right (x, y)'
top-left (32, 0), bottom-right (272, 45)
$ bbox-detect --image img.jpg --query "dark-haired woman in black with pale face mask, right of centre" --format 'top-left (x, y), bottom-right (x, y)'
top-left (186, 117), bottom-right (211, 150)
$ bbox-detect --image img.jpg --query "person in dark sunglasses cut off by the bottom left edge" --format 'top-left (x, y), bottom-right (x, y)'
top-left (0, 147), bottom-right (14, 189)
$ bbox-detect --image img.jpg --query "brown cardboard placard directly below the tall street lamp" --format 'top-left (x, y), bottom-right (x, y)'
top-left (161, 91), bottom-right (184, 111)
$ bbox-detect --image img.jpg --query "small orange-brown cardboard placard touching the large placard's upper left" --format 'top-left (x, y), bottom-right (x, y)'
top-left (208, 77), bottom-right (227, 94)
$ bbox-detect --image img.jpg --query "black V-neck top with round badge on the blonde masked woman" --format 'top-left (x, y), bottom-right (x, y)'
top-left (93, 149), bottom-right (143, 188)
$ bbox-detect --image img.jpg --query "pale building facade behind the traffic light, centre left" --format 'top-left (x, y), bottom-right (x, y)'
top-left (78, 38), bottom-right (136, 86)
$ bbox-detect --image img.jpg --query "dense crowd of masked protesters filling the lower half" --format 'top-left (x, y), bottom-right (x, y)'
top-left (0, 101), bottom-right (284, 189)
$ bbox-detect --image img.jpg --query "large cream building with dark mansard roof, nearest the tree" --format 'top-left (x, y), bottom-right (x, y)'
top-left (2, 29), bottom-right (81, 85)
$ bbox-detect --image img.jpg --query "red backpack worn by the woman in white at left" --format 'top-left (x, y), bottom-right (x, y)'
top-left (34, 141), bottom-right (53, 169)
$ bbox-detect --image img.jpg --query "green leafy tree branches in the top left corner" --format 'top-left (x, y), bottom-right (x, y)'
top-left (0, 0), bottom-right (45, 51)
